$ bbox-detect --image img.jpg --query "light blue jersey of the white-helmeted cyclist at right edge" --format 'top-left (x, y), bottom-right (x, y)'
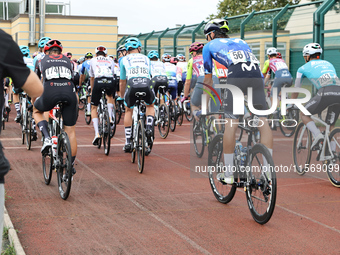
top-left (295, 59), bottom-right (340, 90)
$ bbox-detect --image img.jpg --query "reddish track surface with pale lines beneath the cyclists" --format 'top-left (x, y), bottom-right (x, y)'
top-left (1, 108), bottom-right (340, 254)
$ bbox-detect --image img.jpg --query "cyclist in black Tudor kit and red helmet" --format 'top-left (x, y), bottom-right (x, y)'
top-left (34, 40), bottom-right (77, 174)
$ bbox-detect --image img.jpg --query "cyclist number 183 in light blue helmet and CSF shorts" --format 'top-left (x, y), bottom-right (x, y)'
top-left (120, 37), bottom-right (155, 152)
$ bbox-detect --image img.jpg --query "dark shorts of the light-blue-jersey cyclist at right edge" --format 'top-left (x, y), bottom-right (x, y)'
top-left (305, 85), bottom-right (340, 125)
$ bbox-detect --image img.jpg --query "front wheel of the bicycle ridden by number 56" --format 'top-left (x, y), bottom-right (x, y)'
top-left (208, 134), bottom-right (236, 204)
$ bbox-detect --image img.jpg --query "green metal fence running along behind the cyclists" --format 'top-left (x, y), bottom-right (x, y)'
top-left (117, 0), bottom-right (340, 75)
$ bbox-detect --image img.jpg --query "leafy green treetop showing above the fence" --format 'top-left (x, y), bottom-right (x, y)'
top-left (208, 0), bottom-right (300, 19)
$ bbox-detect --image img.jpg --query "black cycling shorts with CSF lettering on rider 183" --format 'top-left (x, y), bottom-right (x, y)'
top-left (124, 78), bottom-right (155, 108)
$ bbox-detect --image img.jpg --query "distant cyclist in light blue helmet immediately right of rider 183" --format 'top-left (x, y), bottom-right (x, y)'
top-left (148, 50), bottom-right (168, 103)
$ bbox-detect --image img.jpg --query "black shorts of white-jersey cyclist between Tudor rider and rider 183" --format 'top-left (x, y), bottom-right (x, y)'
top-left (91, 77), bottom-right (116, 106)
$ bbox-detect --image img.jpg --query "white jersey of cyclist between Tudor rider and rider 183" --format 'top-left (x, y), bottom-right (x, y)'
top-left (89, 56), bottom-right (114, 78)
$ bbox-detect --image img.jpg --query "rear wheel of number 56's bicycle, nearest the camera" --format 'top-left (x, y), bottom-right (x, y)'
top-left (246, 143), bottom-right (277, 224)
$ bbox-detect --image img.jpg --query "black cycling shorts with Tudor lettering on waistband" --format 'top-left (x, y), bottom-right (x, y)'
top-left (34, 81), bottom-right (78, 126)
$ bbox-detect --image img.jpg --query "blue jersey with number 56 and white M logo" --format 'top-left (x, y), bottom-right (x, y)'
top-left (203, 38), bottom-right (259, 74)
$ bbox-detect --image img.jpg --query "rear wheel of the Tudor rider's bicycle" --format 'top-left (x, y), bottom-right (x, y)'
top-left (57, 132), bottom-right (72, 200)
